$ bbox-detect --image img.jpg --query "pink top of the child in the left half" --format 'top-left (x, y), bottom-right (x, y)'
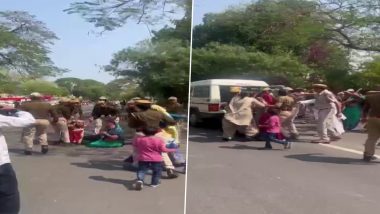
top-left (132, 136), bottom-right (175, 162)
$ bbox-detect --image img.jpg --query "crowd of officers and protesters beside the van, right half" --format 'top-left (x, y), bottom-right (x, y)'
top-left (222, 84), bottom-right (380, 161)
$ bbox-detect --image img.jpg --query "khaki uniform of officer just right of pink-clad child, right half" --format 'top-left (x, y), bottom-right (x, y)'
top-left (276, 96), bottom-right (298, 136)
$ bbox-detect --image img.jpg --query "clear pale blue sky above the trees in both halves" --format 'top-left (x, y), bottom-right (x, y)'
top-left (0, 0), bottom-right (255, 83)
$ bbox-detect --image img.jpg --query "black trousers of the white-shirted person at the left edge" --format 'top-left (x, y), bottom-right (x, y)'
top-left (0, 163), bottom-right (20, 214)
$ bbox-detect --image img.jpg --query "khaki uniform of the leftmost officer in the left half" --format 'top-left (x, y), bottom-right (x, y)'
top-left (20, 101), bottom-right (57, 151)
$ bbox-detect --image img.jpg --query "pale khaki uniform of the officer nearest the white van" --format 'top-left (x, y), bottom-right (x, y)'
top-left (222, 96), bottom-right (265, 138)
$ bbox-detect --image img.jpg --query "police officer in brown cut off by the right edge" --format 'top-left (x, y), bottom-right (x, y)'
top-left (362, 91), bottom-right (380, 162)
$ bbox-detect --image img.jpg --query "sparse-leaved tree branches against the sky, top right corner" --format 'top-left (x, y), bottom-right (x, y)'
top-left (315, 0), bottom-right (380, 52)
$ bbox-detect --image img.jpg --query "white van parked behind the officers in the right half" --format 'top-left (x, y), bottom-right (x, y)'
top-left (189, 79), bottom-right (269, 126)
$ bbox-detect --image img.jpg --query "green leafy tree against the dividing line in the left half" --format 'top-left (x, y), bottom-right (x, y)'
top-left (104, 40), bottom-right (190, 102)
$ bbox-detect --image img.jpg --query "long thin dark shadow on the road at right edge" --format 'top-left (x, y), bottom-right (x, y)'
top-left (285, 153), bottom-right (380, 165)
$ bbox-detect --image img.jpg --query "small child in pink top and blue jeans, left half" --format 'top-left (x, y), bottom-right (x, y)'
top-left (132, 127), bottom-right (175, 190)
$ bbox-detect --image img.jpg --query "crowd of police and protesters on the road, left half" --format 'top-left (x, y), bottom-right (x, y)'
top-left (0, 93), bottom-right (185, 213)
